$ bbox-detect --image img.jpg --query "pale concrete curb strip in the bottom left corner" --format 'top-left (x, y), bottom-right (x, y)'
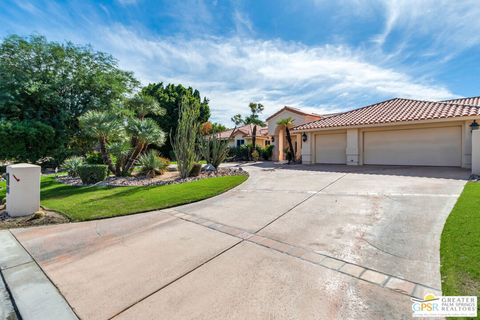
top-left (0, 230), bottom-right (78, 320)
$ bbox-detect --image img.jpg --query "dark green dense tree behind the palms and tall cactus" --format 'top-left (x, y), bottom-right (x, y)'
top-left (141, 83), bottom-right (210, 156)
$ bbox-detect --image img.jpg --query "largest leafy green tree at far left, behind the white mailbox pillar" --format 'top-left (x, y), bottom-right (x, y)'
top-left (0, 35), bottom-right (139, 161)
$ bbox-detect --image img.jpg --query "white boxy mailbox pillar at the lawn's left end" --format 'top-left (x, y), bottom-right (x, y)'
top-left (6, 163), bottom-right (41, 217)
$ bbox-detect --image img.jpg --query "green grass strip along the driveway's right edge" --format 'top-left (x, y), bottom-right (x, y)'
top-left (440, 182), bottom-right (480, 314)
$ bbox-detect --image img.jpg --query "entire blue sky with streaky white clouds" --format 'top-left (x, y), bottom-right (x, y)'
top-left (0, 0), bottom-right (480, 125)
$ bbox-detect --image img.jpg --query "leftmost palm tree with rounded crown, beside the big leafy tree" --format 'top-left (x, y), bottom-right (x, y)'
top-left (79, 111), bottom-right (124, 173)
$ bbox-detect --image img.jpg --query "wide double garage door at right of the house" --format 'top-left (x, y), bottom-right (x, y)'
top-left (363, 127), bottom-right (462, 166)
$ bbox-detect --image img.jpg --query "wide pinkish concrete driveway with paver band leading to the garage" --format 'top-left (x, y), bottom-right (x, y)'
top-left (6, 164), bottom-right (469, 319)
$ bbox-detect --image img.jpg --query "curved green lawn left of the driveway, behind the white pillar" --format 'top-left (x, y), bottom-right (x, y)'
top-left (0, 176), bottom-right (247, 221)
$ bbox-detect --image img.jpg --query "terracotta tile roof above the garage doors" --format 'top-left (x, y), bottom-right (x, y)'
top-left (293, 98), bottom-right (480, 130)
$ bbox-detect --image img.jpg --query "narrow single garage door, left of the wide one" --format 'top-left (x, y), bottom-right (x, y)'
top-left (315, 133), bottom-right (347, 164)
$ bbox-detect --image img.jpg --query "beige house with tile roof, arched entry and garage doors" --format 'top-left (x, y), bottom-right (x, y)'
top-left (267, 97), bottom-right (480, 168)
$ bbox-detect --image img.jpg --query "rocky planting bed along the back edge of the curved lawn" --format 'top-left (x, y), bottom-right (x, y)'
top-left (57, 168), bottom-right (248, 187)
